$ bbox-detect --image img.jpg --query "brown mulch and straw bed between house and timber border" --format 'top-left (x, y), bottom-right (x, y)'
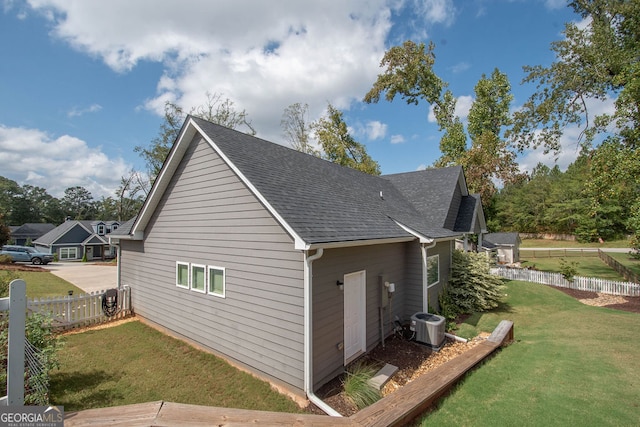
top-left (307, 334), bottom-right (489, 417)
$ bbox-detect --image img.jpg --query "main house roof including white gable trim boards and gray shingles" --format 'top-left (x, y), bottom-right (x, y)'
top-left (131, 117), bottom-right (480, 249)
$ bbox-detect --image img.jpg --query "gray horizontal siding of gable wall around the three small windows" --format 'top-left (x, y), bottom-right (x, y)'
top-left (120, 137), bottom-right (304, 390)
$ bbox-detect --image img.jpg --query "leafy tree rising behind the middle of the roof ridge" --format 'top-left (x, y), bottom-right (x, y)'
top-left (311, 104), bottom-right (380, 175)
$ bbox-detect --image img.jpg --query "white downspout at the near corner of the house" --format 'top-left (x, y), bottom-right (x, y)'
top-left (304, 248), bottom-right (342, 417)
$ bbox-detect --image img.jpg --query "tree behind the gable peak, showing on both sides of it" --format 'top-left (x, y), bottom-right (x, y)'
top-left (134, 92), bottom-right (256, 183)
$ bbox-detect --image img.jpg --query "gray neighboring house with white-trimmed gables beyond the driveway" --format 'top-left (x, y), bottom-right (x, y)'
top-left (33, 220), bottom-right (120, 261)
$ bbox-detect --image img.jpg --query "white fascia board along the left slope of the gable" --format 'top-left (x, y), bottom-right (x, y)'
top-left (129, 119), bottom-right (202, 240)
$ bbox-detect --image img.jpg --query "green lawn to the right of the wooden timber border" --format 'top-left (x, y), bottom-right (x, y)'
top-left (422, 282), bottom-right (640, 426)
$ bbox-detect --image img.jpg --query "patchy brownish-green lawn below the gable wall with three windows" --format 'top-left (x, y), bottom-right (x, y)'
top-left (51, 322), bottom-right (301, 413)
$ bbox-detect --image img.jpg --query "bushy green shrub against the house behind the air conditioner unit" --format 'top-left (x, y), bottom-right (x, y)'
top-left (439, 251), bottom-right (503, 320)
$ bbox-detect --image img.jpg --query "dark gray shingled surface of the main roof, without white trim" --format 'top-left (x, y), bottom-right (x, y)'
top-left (193, 118), bottom-right (461, 243)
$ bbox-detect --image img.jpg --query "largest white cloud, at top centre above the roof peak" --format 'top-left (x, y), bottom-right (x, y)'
top-left (29, 0), bottom-right (404, 141)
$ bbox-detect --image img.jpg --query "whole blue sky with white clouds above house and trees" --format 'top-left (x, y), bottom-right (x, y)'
top-left (0, 0), bottom-right (592, 199)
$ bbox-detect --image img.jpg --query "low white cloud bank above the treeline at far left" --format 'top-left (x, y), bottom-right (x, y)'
top-left (0, 125), bottom-right (131, 199)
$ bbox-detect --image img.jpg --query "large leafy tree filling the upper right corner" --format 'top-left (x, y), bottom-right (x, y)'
top-left (510, 0), bottom-right (640, 152)
